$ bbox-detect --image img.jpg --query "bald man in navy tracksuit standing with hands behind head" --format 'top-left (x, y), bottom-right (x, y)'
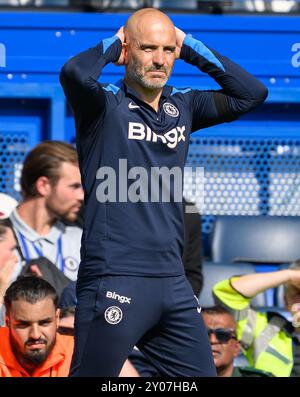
top-left (60, 9), bottom-right (267, 377)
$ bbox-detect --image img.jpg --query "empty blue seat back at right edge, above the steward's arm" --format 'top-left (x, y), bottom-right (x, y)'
top-left (212, 216), bottom-right (300, 264)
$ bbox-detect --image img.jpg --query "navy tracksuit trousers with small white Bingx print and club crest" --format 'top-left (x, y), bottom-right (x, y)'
top-left (70, 275), bottom-right (216, 377)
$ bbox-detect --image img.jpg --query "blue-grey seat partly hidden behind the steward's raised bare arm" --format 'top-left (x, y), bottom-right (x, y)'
top-left (199, 262), bottom-right (267, 308)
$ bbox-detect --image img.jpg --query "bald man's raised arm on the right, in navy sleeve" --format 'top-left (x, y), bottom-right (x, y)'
top-left (177, 29), bottom-right (268, 131)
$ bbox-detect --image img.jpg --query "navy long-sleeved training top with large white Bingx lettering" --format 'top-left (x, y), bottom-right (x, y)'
top-left (60, 36), bottom-right (267, 277)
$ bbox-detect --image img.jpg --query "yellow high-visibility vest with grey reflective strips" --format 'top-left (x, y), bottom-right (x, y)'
top-left (213, 277), bottom-right (294, 377)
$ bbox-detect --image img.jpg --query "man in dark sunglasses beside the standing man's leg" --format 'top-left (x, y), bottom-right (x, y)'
top-left (202, 306), bottom-right (270, 377)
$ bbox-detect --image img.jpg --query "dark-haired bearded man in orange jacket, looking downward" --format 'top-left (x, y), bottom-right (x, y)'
top-left (0, 277), bottom-right (74, 377)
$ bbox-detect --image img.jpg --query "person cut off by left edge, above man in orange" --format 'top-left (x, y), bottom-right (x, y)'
top-left (0, 220), bottom-right (18, 326)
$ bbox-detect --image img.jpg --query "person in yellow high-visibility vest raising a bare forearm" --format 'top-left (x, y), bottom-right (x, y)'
top-left (213, 261), bottom-right (300, 377)
